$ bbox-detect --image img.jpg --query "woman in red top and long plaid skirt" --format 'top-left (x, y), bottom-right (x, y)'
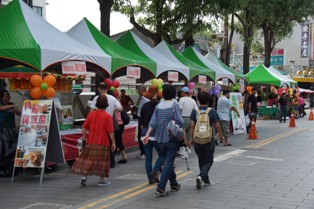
top-left (71, 95), bottom-right (116, 186)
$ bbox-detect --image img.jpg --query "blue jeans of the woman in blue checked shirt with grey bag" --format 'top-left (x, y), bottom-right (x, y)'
top-left (157, 140), bottom-right (179, 190)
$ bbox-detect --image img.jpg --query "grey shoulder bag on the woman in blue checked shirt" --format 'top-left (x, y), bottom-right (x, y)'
top-left (167, 104), bottom-right (185, 142)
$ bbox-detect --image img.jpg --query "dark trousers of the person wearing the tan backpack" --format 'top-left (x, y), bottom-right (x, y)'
top-left (194, 140), bottom-right (215, 183)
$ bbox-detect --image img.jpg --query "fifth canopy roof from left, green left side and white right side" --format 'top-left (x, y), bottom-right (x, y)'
top-left (182, 47), bottom-right (235, 83)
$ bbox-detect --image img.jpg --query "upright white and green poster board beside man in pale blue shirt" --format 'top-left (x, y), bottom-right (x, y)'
top-left (230, 92), bottom-right (246, 134)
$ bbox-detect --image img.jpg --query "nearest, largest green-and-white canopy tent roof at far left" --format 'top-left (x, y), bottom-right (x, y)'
top-left (0, 0), bottom-right (111, 73)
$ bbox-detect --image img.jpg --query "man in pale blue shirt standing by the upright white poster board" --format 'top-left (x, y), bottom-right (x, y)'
top-left (217, 90), bottom-right (240, 146)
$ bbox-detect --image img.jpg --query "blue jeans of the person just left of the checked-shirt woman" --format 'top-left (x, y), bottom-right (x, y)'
top-left (144, 140), bottom-right (165, 181)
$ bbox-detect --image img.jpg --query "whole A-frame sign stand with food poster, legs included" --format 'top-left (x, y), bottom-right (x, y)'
top-left (11, 100), bottom-right (66, 184)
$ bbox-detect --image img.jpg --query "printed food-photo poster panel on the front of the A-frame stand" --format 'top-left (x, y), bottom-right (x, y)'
top-left (14, 100), bottom-right (53, 168)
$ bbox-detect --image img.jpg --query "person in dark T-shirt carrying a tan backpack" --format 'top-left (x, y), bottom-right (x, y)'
top-left (187, 91), bottom-right (224, 189)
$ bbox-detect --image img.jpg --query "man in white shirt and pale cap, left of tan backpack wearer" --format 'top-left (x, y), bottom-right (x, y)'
top-left (179, 87), bottom-right (197, 144)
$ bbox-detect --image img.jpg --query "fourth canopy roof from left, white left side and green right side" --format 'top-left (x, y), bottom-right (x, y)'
top-left (155, 41), bottom-right (215, 80)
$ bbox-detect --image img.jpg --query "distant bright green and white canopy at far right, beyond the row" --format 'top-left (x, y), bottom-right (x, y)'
top-left (246, 64), bottom-right (289, 87)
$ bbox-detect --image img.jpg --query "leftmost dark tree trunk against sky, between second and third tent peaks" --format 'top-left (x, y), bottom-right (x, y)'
top-left (98, 0), bottom-right (113, 37)
